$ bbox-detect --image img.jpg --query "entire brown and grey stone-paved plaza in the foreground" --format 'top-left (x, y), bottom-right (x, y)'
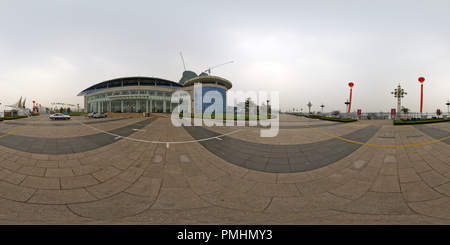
top-left (0, 115), bottom-right (450, 224)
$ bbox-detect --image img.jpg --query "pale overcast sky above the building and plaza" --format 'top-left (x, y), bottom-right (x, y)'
top-left (0, 0), bottom-right (450, 112)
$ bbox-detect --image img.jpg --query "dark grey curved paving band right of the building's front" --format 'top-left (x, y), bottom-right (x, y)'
top-left (184, 126), bottom-right (381, 173)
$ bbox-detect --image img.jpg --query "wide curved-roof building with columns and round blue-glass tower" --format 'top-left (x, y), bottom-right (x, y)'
top-left (78, 73), bottom-right (232, 113)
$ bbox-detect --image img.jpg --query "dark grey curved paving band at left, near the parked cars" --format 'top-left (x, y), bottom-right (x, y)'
top-left (0, 118), bottom-right (156, 155)
